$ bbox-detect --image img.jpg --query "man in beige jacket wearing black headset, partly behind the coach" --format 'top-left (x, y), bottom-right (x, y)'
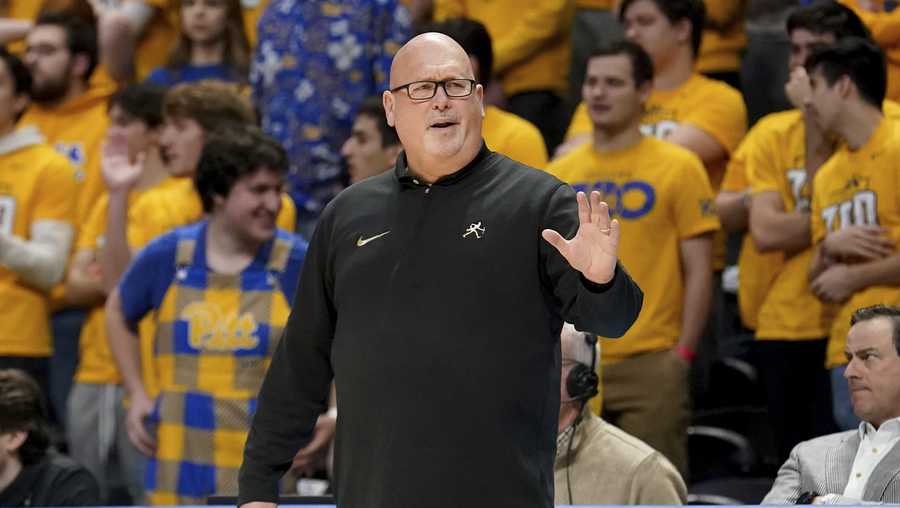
top-left (553, 323), bottom-right (687, 505)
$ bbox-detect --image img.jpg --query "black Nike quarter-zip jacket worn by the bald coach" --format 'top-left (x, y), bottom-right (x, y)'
top-left (239, 146), bottom-right (643, 508)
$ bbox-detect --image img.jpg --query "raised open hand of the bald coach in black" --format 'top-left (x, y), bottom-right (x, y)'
top-left (541, 191), bottom-right (619, 284)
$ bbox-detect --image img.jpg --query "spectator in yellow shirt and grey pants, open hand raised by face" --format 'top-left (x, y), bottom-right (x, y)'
top-left (66, 81), bottom-right (168, 503)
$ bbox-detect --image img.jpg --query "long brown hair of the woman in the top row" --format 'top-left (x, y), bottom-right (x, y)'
top-left (166, 0), bottom-right (250, 83)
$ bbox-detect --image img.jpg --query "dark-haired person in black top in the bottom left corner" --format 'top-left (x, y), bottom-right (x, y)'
top-left (0, 369), bottom-right (100, 506)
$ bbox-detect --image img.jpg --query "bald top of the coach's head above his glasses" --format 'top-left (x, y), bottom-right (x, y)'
top-left (391, 32), bottom-right (475, 88)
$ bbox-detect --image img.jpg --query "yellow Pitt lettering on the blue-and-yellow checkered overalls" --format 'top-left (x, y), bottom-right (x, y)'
top-left (180, 302), bottom-right (259, 351)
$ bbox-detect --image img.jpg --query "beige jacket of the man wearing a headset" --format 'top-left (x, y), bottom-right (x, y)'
top-left (553, 410), bottom-right (687, 505)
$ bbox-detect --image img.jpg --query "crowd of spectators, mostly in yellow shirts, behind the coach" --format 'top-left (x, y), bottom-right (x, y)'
top-left (0, 0), bottom-right (900, 504)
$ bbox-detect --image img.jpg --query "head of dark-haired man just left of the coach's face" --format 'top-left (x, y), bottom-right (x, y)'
top-left (341, 96), bottom-right (403, 183)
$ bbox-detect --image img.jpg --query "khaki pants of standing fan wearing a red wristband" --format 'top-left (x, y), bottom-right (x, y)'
top-left (602, 350), bottom-right (690, 478)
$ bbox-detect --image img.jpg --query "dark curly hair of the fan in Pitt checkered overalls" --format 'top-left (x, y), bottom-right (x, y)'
top-left (194, 124), bottom-right (288, 213)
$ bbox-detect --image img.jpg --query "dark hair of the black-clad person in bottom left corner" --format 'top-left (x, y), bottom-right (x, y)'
top-left (0, 369), bottom-right (50, 465)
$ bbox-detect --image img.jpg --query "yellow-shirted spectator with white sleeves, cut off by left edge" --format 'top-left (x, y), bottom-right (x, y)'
top-left (0, 49), bottom-right (77, 393)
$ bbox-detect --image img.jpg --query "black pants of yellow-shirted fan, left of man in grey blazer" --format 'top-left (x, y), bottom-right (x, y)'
top-left (753, 339), bottom-right (837, 464)
